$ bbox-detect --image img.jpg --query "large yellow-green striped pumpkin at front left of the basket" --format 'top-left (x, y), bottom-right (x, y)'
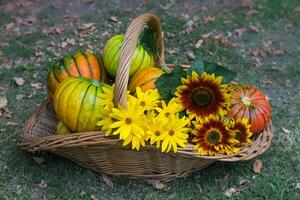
top-left (53, 77), bottom-right (111, 132)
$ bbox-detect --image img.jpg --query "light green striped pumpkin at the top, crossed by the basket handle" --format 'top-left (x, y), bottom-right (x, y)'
top-left (103, 35), bottom-right (154, 78)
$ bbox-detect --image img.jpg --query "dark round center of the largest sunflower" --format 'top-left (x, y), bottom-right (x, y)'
top-left (191, 88), bottom-right (213, 107)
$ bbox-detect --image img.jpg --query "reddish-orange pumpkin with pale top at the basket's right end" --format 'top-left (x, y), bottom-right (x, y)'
top-left (227, 85), bottom-right (271, 134)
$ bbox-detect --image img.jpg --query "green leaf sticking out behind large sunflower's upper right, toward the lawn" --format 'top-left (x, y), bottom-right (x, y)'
top-left (204, 60), bottom-right (236, 83)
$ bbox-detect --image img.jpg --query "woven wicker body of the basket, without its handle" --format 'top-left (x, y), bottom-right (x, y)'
top-left (20, 99), bottom-right (272, 180)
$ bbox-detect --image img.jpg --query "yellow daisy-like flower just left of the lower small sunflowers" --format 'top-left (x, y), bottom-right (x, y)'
top-left (158, 114), bottom-right (190, 153)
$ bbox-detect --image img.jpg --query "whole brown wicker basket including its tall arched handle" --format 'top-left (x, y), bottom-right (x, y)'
top-left (20, 13), bottom-right (273, 180)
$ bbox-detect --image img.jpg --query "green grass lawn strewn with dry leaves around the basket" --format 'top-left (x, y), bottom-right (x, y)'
top-left (0, 0), bottom-right (300, 200)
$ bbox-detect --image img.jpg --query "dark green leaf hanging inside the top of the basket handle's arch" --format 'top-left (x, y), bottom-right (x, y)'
top-left (140, 27), bottom-right (157, 56)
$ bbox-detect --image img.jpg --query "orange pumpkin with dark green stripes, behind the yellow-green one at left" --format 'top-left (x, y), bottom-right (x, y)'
top-left (47, 51), bottom-right (106, 97)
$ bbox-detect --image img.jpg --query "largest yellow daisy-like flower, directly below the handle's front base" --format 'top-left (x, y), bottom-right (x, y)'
top-left (109, 98), bottom-right (146, 150)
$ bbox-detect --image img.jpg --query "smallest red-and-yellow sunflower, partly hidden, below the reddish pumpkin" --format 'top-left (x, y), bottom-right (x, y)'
top-left (230, 118), bottom-right (252, 146)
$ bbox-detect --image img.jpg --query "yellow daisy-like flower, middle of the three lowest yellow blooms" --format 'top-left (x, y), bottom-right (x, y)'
top-left (146, 112), bottom-right (168, 148)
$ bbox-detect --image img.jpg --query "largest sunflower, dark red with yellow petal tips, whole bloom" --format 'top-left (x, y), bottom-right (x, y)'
top-left (175, 71), bottom-right (230, 119)
